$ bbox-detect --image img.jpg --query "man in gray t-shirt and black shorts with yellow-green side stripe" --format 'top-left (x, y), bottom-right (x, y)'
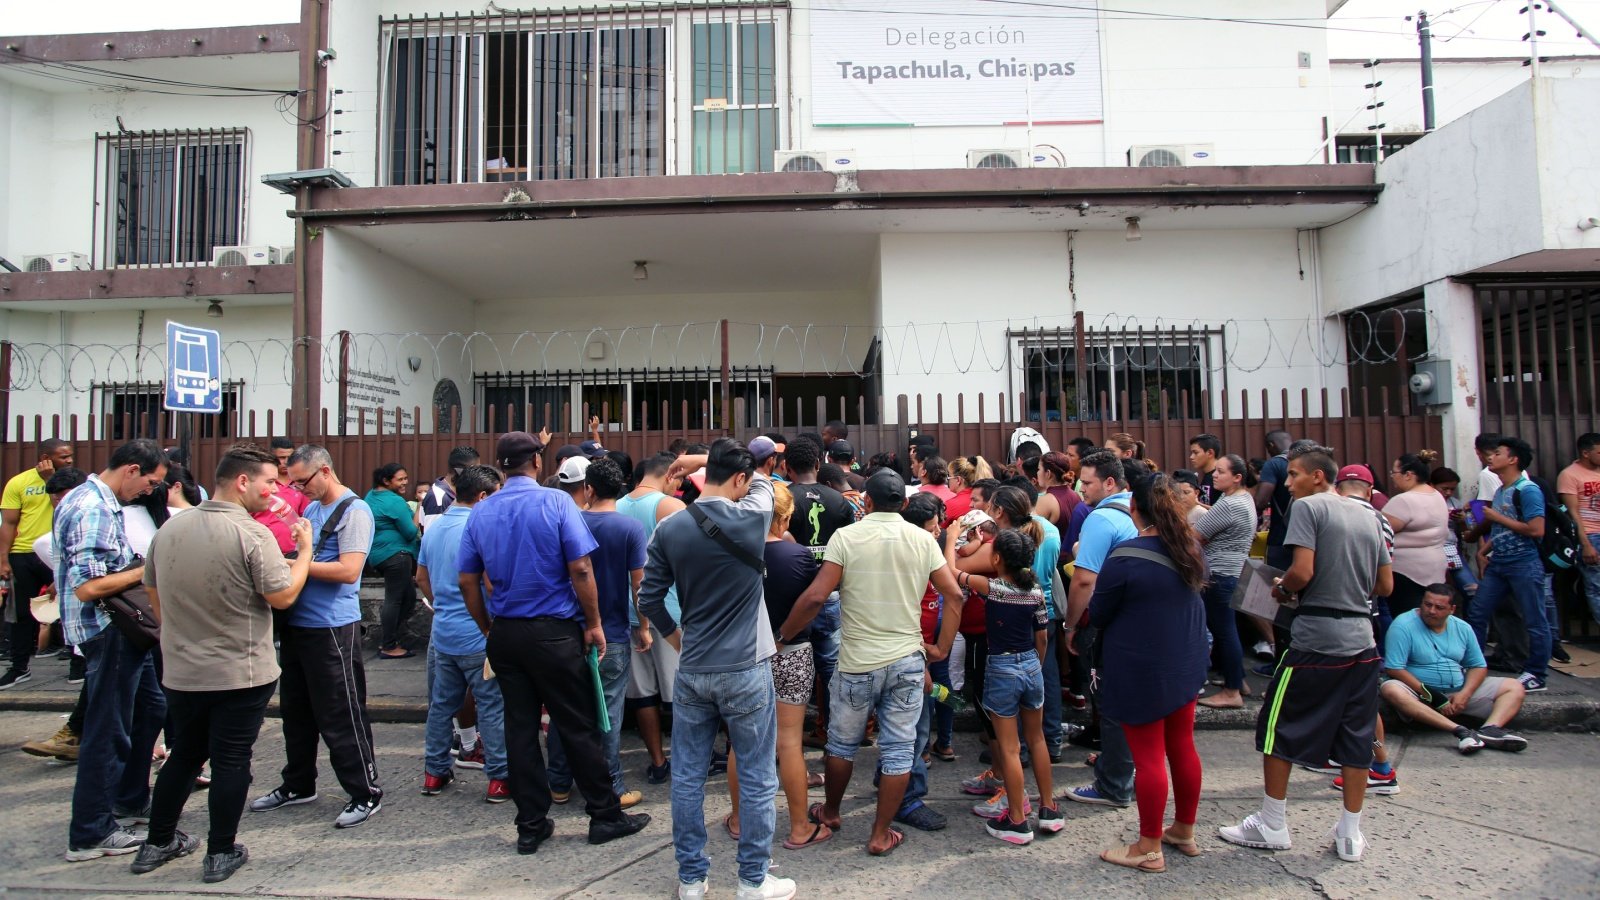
top-left (1219, 445), bottom-right (1394, 862)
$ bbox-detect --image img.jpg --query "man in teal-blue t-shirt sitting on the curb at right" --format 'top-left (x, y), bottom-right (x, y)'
top-left (1378, 585), bottom-right (1528, 754)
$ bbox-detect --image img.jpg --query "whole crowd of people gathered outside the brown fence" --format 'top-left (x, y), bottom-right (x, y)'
top-left (0, 421), bottom-right (1600, 898)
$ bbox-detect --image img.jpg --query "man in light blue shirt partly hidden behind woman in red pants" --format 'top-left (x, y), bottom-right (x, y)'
top-left (1066, 450), bottom-right (1146, 807)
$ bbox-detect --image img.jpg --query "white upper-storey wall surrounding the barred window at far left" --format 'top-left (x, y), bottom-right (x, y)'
top-left (0, 85), bottom-right (294, 266)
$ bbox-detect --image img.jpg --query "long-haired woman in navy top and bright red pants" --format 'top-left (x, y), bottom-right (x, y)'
top-left (1090, 474), bottom-right (1206, 871)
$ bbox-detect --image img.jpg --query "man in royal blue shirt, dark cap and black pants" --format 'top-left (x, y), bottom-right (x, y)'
top-left (456, 431), bottom-right (650, 854)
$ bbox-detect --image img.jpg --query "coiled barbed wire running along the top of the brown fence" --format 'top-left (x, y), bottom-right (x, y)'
top-left (0, 309), bottom-right (1438, 394)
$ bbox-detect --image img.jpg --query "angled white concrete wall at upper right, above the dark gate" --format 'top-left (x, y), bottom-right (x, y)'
top-left (1322, 78), bottom-right (1548, 311)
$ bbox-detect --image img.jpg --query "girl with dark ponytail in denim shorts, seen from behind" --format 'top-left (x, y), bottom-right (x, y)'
top-left (944, 522), bottom-right (1066, 844)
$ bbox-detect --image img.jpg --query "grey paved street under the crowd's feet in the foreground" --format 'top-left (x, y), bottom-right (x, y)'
top-left (0, 711), bottom-right (1600, 898)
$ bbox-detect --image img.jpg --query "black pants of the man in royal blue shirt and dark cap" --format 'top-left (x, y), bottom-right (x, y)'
top-left (488, 618), bottom-right (622, 834)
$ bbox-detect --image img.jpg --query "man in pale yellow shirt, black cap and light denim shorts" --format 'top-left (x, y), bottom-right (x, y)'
top-left (777, 469), bottom-right (962, 855)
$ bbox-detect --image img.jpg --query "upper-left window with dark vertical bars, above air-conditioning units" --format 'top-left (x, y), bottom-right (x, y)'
top-left (94, 128), bottom-right (250, 266)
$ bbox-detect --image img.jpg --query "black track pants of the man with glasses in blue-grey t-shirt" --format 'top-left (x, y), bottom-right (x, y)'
top-left (278, 621), bottom-right (384, 802)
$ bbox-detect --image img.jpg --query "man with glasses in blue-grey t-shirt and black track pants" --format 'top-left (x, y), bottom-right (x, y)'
top-left (250, 444), bottom-right (384, 828)
